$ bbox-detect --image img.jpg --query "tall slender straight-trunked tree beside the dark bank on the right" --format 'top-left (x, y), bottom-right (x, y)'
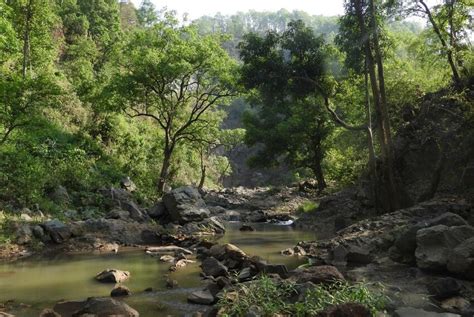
top-left (339, 0), bottom-right (400, 211)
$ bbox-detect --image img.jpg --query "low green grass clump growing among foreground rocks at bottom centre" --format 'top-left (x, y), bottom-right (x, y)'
top-left (218, 276), bottom-right (386, 317)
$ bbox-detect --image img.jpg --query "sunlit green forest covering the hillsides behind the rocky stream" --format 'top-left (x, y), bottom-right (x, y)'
top-left (0, 0), bottom-right (474, 212)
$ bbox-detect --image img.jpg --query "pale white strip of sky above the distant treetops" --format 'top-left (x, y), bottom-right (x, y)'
top-left (132, 0), bottom-right (343, 19)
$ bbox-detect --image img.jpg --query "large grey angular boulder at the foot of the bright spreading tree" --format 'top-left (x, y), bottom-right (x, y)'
top-left (163, 186), bottom-right (210, 224)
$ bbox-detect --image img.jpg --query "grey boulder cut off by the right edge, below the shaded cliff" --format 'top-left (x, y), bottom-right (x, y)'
top-left (447, 237), bottom-right (474, 280)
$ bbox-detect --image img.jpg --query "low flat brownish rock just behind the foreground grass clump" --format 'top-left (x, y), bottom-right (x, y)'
top-left (291, 265), bottom-right (345, 284)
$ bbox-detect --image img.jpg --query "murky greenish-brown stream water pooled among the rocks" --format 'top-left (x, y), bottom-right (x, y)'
top-left (0, 223), bottom-right (314, 317)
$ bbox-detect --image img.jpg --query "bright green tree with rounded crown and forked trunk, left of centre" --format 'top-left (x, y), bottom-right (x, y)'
top-left (110, 21), bottom-right (236, 193)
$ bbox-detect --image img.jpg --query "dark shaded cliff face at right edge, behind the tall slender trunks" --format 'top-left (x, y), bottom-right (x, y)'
top-left (394, 91), bottom-right (474, 204)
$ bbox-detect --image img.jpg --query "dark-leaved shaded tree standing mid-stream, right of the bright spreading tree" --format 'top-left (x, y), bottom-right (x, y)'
top-left (240, 20), bottom-right (331, 191)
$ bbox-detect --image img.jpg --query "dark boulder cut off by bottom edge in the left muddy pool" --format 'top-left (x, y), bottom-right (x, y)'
top-left (74, 297), bottom-right (139, 317)
